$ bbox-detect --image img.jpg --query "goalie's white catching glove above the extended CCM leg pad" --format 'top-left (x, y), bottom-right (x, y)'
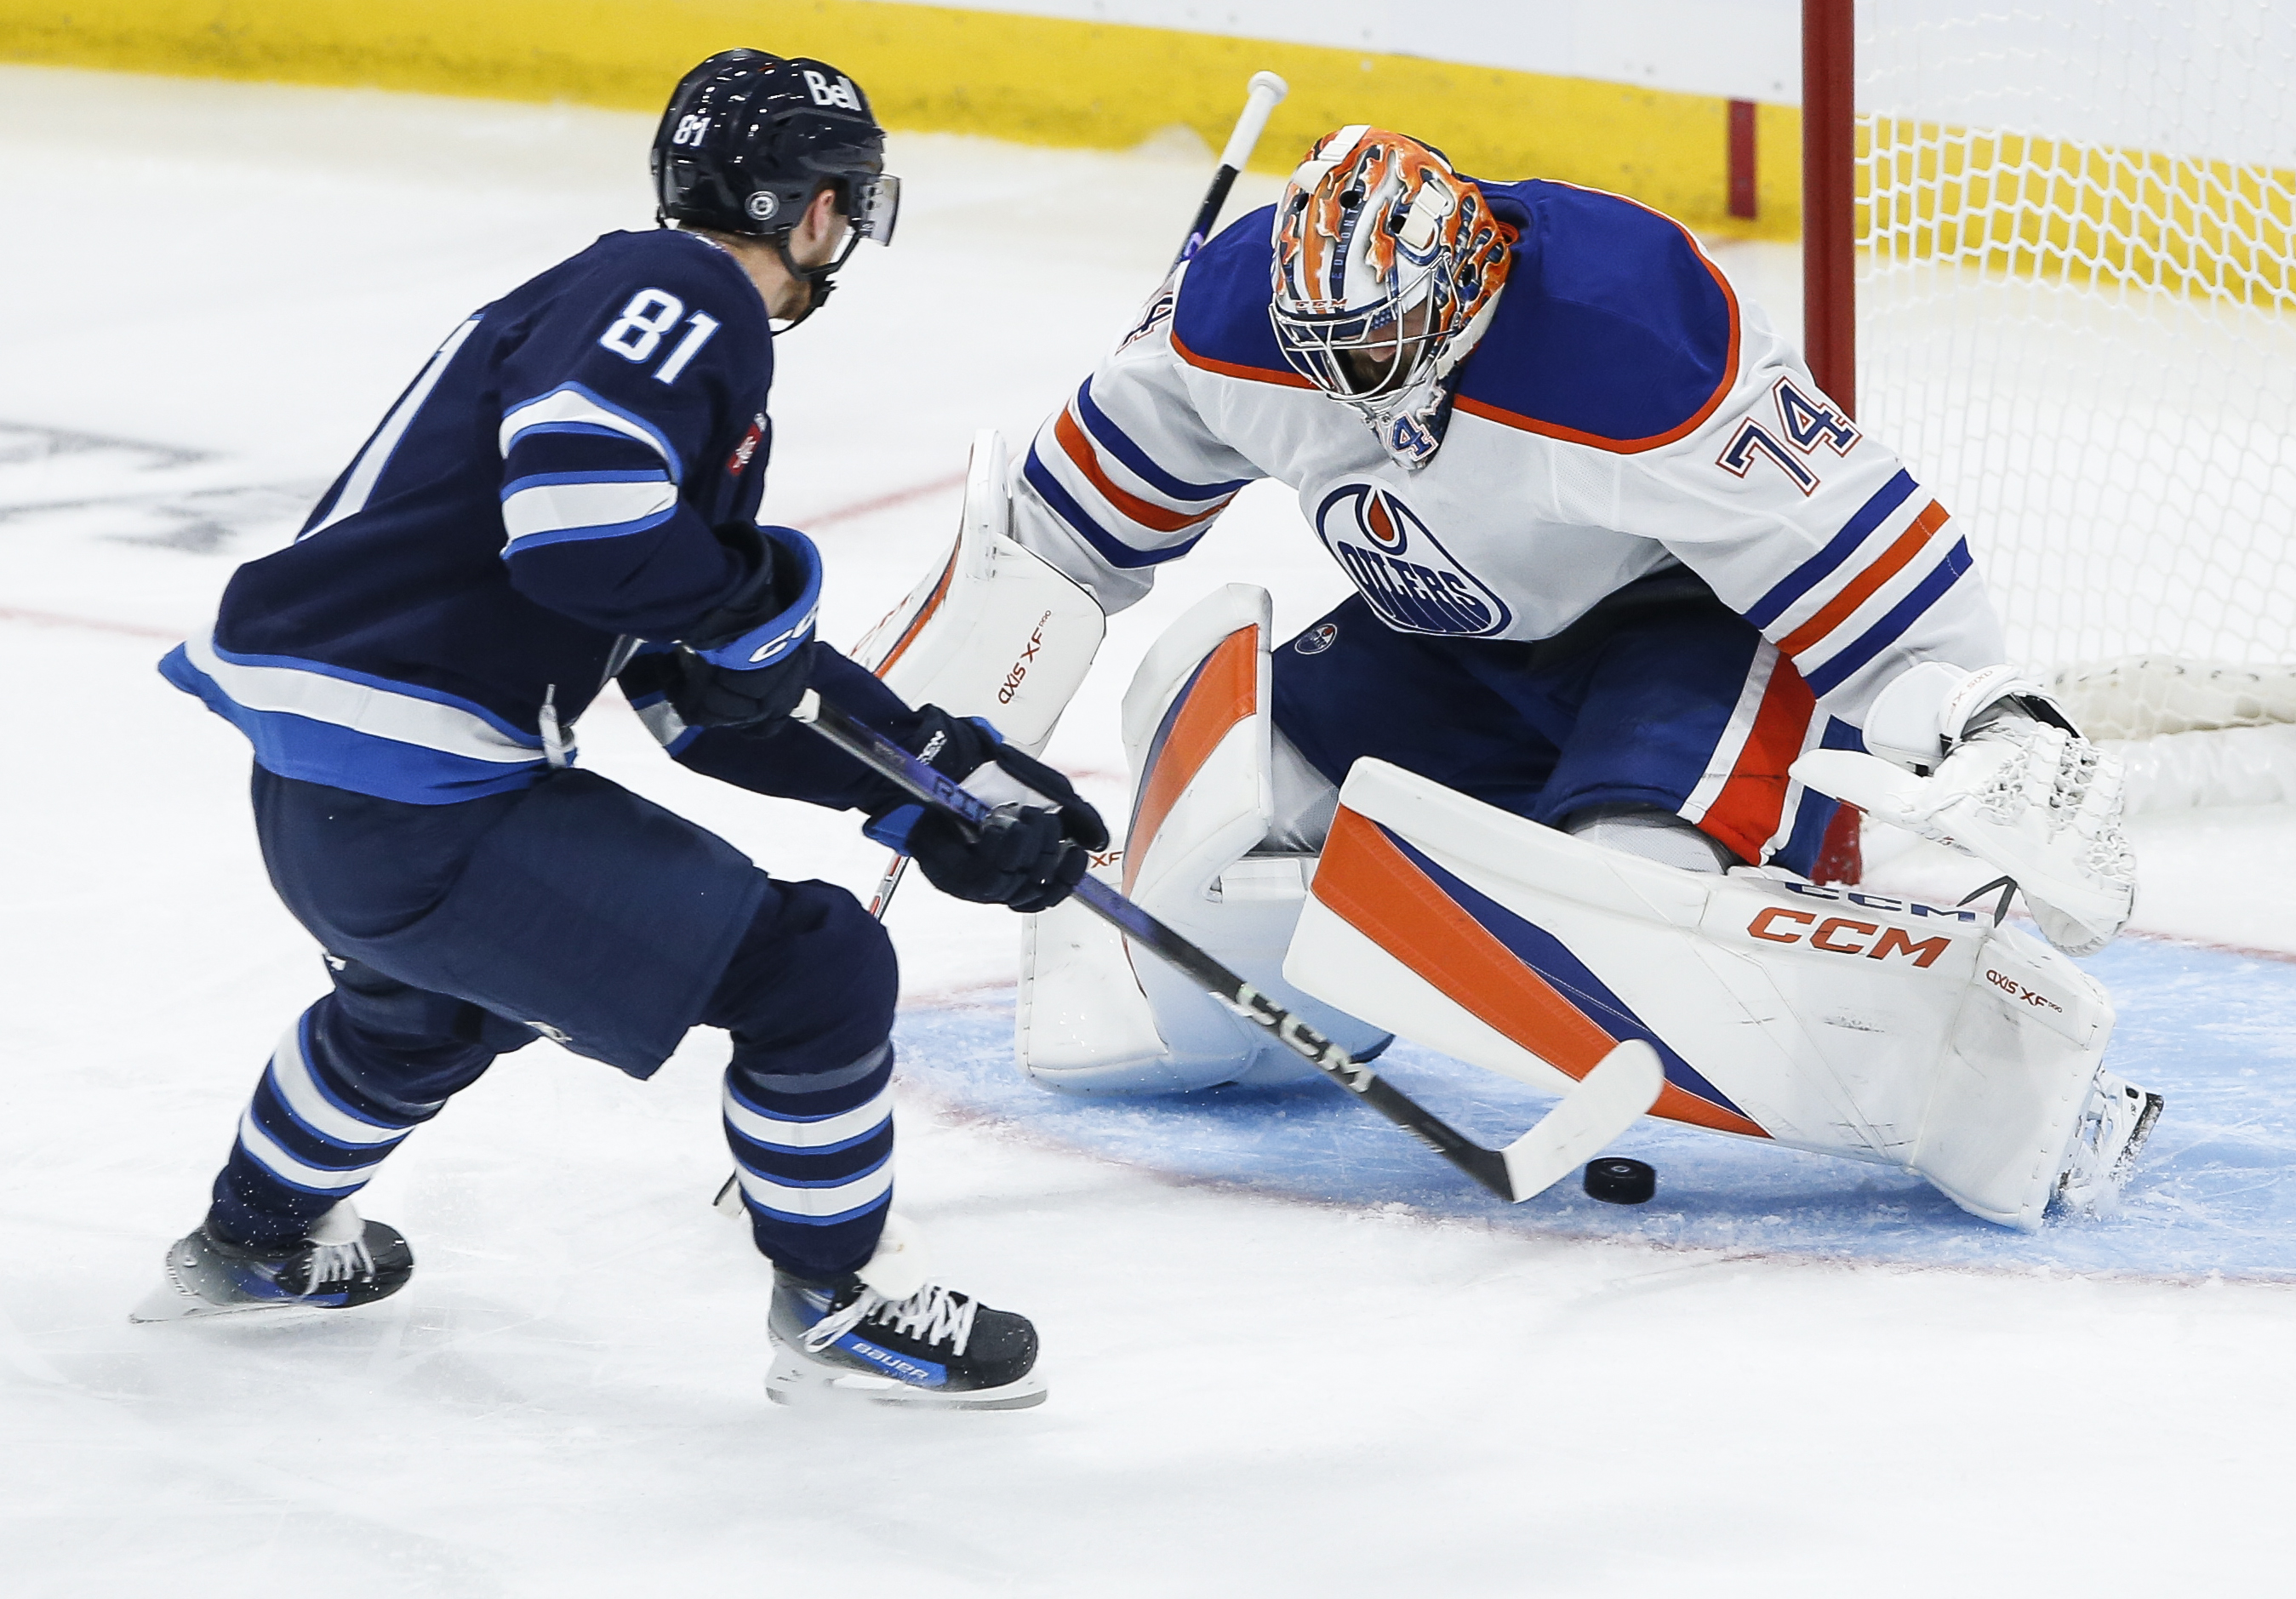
top-left (1793, 662), bottom-right (2135, 956)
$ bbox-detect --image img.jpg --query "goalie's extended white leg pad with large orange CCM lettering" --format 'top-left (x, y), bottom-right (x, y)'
top-left (1283, 761), bottom-right (2112, 1229)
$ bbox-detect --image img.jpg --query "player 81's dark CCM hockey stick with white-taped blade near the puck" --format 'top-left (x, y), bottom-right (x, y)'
top-left (790, 692), bottom-right (1665, 1204)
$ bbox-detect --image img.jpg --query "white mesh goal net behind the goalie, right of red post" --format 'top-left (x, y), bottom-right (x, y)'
top-left (1855, 0), bottom-right (2296, 808)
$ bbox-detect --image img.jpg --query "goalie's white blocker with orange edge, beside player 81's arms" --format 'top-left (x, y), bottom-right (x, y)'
top-left (852, 430), bottom-right (1106, 754)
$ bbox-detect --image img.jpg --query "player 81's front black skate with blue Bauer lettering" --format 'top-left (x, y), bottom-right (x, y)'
top-left (764, 1273), bottom-right (1045, 1411)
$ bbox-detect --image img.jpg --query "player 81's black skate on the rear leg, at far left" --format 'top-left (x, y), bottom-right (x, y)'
top-left (129, 1199), bottom-right (415, 1321)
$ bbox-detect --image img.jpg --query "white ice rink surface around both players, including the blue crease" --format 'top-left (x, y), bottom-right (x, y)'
top-left (0, 69), bottom-right (2296, 1599)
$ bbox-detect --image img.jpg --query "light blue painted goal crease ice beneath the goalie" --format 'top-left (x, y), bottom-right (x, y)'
top-left (898, 937), bottom-right (2296, 1282)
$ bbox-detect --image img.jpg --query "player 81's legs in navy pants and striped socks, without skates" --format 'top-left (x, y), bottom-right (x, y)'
top-left (209, 768), bottom-right (898, 1277)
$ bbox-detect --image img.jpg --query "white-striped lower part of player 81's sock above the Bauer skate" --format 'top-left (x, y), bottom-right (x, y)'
top-left (726, 1043), bottom-right (894, 1280)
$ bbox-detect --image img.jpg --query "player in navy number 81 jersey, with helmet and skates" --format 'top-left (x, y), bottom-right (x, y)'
top-left (138, 50), bottom-right (1106, 1406)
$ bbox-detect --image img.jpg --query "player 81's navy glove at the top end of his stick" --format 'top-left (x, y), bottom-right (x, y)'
top-left (668, 522), bottom-right (822, 728)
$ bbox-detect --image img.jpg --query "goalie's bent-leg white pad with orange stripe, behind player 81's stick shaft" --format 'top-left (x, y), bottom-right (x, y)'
top-left (1015, 584), bottom-right (1385, 1094)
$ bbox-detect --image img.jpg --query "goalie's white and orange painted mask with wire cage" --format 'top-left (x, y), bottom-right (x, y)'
top-left (1267, 124), bottom-right (1516, 466)
